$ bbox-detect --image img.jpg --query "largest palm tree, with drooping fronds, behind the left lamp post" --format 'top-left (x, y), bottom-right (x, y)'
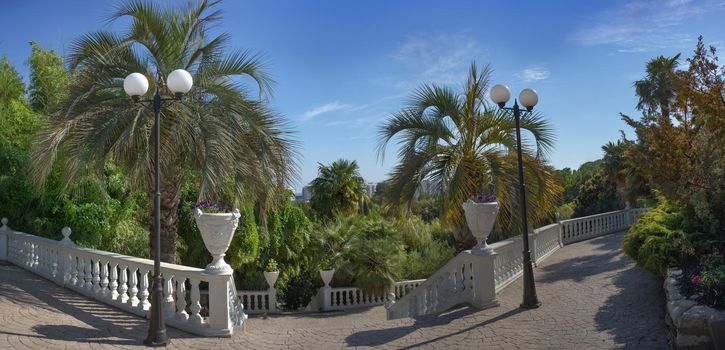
top-left (31, 0), bottom-right (297, 262)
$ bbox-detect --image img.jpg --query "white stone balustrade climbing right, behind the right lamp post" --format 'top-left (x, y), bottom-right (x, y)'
top-left (388, 208), bottom-right (650, 319)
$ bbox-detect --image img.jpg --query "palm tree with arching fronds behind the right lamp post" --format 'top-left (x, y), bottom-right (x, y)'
top-left (378, 62), bottom-right (560, 249)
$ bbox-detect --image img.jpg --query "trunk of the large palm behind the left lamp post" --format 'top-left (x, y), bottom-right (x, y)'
top-left (149, 171), bottom-right (183, 264)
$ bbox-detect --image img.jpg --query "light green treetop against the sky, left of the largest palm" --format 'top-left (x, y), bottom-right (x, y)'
top-left (28, 41), bottom-right (70, 115)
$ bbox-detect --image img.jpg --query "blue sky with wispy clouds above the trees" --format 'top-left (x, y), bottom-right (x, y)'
top-left (0, 0), bottom-right (725, 191)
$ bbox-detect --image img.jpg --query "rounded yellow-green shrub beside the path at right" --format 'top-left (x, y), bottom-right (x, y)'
top-left (622, 199), bottom-right (689, 276)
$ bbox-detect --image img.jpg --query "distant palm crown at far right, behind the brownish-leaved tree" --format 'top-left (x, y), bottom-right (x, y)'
top-left (634, 54), bottom-right (680, 117)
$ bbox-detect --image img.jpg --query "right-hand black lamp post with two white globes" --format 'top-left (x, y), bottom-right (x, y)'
top-left (491, 84), bottom-right (541, 309)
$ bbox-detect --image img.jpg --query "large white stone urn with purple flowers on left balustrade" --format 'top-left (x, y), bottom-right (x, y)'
top-left (194, 208), bottom-right (242, 275)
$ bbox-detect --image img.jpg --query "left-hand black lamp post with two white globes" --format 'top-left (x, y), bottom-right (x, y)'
top-left (123, 69), bottom-right (193, 347)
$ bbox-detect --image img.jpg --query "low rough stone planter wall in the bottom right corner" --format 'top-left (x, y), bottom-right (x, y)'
top-left (664, 269), bottom-right (725, 349)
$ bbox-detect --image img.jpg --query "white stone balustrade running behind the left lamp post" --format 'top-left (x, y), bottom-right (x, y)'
top-left (0, 219), bottom-right (245, 336)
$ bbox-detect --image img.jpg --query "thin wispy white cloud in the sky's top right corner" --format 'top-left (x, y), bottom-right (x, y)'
top-left (571, 0), bottom-right (725, 53)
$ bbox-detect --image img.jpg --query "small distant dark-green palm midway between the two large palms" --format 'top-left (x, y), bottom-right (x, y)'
top-left (310, 159), bottom-right (367, 219)
